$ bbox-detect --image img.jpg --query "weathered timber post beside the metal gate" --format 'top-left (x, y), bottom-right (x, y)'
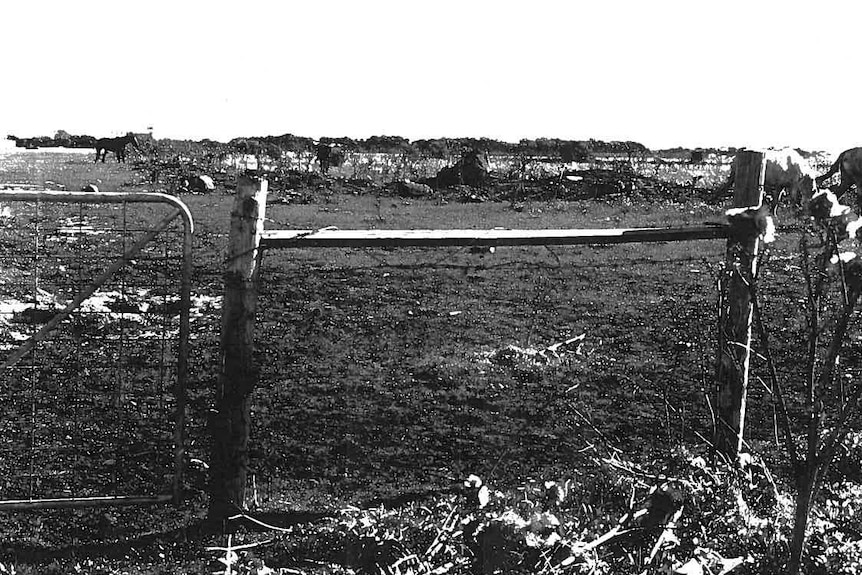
top-left (209, 175), bottom-right (267, 520)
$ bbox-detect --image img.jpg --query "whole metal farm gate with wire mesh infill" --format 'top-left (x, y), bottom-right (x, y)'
top-left (0, 190), bottom-right (193, 510)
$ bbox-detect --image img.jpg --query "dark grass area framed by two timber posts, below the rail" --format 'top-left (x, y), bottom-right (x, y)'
top-left (243, 237), bottom-right (724, 508)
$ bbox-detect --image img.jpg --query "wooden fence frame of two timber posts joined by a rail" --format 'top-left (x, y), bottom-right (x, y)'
top-left (209, 169), bottom-right (764, 520)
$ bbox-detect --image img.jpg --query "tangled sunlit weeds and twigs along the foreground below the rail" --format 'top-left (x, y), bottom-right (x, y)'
top-left (226, 448), bottom-right (820, 574)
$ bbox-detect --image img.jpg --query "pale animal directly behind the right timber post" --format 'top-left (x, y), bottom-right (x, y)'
top-left (713, 148), bottom-right (817, 207)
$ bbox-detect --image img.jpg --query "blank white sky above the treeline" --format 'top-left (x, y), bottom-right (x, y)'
top-left (0, 0), bottom-right (862, 152)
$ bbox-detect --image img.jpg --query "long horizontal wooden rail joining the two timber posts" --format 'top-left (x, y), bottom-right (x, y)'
top-left (260, 224), bottom-right (728, 248)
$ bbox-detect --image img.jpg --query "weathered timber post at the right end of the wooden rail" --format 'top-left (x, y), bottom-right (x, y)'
top-left (715, 151), bottom-right (766, 461)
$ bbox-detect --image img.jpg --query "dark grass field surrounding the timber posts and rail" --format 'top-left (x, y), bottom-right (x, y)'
top-left (0, 151), bottom-right (855, 573)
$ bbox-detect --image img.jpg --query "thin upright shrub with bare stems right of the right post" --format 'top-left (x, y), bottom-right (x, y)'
top-left (736, 191), bottom-right (862, 574)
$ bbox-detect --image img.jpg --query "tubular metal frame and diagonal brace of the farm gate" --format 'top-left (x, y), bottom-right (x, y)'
top-left (0, 189), bottom-right (194, 512)
